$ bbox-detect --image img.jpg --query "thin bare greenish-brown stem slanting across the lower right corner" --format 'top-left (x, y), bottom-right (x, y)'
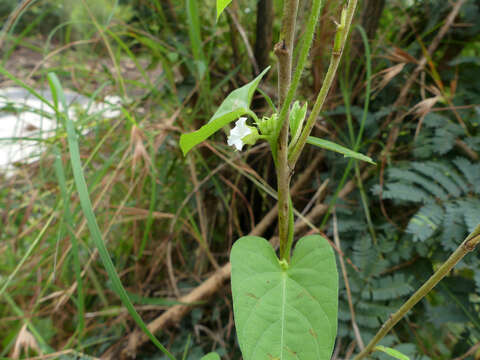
top-left (354, 224), bottom-right (480, 360)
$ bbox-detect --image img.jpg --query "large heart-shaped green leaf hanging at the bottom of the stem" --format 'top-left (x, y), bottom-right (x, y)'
top-left (230, 235), bottom-right (338, 360)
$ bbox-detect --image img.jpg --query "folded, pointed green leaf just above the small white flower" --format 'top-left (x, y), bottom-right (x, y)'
top-left (180, 66), bottom-right (270, 155)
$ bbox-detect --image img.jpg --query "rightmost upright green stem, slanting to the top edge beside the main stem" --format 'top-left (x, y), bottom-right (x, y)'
top-left (288, 0), bottom-right (358, 168)
